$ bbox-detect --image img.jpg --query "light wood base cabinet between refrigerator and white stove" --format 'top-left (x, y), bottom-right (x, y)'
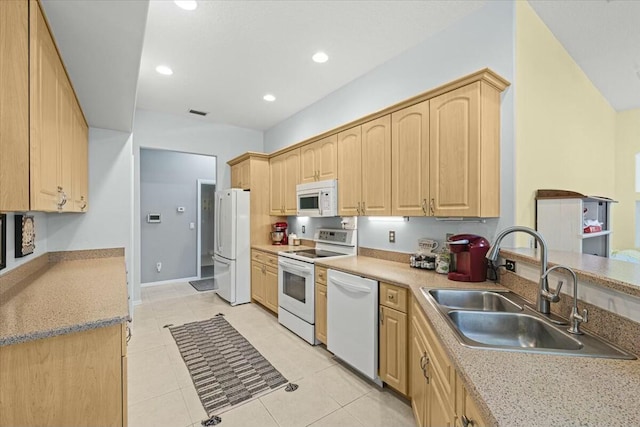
top-left (251, 249), bottom-right (278, 314)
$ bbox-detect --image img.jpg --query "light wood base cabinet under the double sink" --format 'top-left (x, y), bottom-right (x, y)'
top-left (409, 300), bottom-right (485, 427)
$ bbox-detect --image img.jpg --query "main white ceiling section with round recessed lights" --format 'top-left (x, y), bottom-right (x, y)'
top-left (138, 0), bottom-right (484, 130)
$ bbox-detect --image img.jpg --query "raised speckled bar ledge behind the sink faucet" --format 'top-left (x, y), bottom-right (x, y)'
top-left (500, 248), bottom-right (640, 297)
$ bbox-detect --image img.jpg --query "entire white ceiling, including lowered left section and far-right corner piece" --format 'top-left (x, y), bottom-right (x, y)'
top-left (43, 0), bottom-right (640, 131)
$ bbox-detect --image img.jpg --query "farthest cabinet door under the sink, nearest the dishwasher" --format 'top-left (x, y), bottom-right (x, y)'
top-left (409, 316), bottom-right (428, 427)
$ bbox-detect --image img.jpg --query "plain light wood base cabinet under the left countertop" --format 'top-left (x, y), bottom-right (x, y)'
top-left (0, 324), bottom-right (127, 426)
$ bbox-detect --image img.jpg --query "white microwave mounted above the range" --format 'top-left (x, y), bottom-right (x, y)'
top-left (296, 179), bottom-right (338, 217)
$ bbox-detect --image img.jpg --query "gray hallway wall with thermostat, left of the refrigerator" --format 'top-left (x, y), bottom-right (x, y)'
top-left (140, 149), bottom-right (216, 283)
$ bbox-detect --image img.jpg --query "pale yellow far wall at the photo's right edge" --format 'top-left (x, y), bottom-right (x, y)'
top-left (611, 109), bottom-right (640, 249)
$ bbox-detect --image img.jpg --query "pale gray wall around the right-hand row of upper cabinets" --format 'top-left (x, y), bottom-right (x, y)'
top-left (264, 2), bottom-right (515, 252)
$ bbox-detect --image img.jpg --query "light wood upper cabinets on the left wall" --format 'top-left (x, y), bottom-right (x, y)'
top-left (0, 0), bottom-right (88, 212)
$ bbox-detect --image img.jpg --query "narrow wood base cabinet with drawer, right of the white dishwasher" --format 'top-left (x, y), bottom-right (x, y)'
top-left (378, 282), bottom-right (409, 395)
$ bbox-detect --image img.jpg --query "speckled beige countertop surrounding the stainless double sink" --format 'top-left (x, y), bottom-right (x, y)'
top-left (317, 256), bottom-right (640, 426)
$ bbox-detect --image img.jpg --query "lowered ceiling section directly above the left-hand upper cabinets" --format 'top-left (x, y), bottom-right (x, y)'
top-left (40, 0), bottom-right (149, 132)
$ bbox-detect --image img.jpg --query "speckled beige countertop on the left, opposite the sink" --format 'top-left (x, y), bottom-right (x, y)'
top-left (0, 253), bottom-right (129, 346)
